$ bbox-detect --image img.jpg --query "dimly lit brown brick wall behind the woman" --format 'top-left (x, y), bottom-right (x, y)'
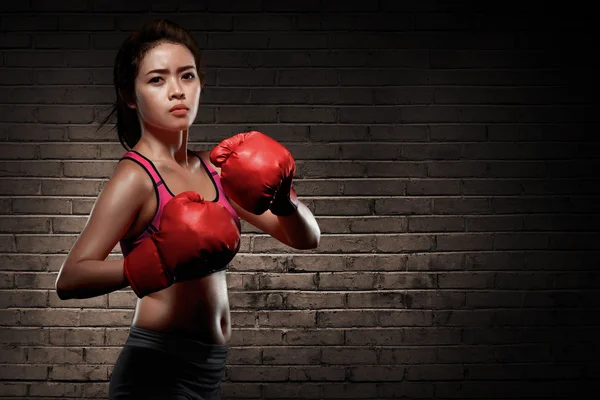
top-left (0, 0), bottom-right (600, 400)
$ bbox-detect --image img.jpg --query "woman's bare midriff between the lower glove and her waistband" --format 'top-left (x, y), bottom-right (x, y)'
top-left (132, 270), bottom-right (231, 344)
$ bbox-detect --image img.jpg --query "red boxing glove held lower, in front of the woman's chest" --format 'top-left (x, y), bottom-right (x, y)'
top-left (123, 191), bottom-right (240, 298)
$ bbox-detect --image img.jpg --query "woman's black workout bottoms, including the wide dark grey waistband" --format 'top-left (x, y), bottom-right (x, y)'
top-left (108, 326), bottom-right (229, 400)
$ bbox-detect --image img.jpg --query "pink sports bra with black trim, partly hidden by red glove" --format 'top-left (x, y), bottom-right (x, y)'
top-left (119, 150), bottom-right (241, 257)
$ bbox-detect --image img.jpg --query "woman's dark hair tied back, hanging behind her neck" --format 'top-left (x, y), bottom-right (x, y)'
top-left (98, 19), bottom-right (204, 150)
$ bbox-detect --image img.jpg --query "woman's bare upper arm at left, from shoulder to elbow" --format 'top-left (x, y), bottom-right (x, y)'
top-left (61, 159), bottom-right (153, 274)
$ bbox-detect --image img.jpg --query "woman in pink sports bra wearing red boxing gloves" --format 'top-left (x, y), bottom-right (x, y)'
top-left (56, 20), bottom-right (320, 399)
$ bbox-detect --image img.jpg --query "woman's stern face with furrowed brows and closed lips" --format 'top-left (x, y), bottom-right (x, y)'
top-left (130, 43), bottom-right (201, 131)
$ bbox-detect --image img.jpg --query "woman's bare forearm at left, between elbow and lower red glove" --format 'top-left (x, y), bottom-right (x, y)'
top-left (56, 259), bottom-right (129, 300)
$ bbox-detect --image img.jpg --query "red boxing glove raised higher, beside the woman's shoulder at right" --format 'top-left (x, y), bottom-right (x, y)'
top-left (210, 131), bottom-right (298, 215)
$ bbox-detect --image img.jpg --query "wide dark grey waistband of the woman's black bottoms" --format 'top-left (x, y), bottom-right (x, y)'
top-left (125, 326), bottom-right (229, 364)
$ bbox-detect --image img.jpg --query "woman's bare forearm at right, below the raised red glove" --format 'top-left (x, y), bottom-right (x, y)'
top-left (277, 201), bottom-right (321, 250)
